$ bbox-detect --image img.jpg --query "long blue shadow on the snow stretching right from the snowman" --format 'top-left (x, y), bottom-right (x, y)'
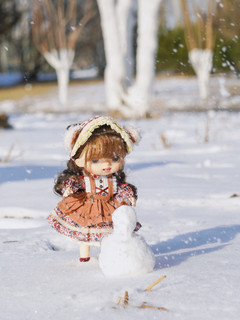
top-left (151, 225), bottom-right (240, 269)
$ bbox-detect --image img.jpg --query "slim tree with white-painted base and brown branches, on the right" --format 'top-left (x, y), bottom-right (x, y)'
top-left (181, 0), bottom-right (214, 99)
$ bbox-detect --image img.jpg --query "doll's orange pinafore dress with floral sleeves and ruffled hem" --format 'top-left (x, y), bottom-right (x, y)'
top-left (48, 176), bottom-right (136, 242)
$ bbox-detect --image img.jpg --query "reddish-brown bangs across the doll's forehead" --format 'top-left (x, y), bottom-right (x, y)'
top-left (85, 135), bottom-right (127, 161)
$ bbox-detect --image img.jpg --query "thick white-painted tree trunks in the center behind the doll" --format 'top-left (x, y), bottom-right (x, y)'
top-left (97, 0), bottom-right (161, 117)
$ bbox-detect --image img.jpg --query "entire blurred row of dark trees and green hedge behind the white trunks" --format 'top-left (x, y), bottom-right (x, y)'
top-left (0, 0), bottom-right (240, 82)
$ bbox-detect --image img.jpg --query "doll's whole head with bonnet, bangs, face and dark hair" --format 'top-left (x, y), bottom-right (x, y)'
top-left (54, 116), bottom-right (140, 195)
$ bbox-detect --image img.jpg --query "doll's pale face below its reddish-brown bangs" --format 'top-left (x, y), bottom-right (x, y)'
top-left (86, 156), bottom-right (123, 176)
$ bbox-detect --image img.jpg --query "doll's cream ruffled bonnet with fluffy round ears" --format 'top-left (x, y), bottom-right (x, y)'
top-left (64, 116), bottom-right (140, 157)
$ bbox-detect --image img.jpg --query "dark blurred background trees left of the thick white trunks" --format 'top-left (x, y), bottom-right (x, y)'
top-left (0, 0), bottom-right (105, 82)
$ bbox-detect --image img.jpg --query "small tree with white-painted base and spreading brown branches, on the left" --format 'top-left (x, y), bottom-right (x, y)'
top-left (31, 0), bottom-right (95, 105)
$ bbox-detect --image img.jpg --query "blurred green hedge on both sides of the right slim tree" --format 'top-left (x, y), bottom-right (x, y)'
top-left (156, 0), bottom-right (240, 74)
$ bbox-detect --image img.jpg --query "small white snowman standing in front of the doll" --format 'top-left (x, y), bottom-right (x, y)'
top-left (99, 205), bottom-right (155, 277)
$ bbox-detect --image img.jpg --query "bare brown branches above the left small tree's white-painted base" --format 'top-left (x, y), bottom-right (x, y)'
top-left (31, 0), bottom-right (96, 53)
